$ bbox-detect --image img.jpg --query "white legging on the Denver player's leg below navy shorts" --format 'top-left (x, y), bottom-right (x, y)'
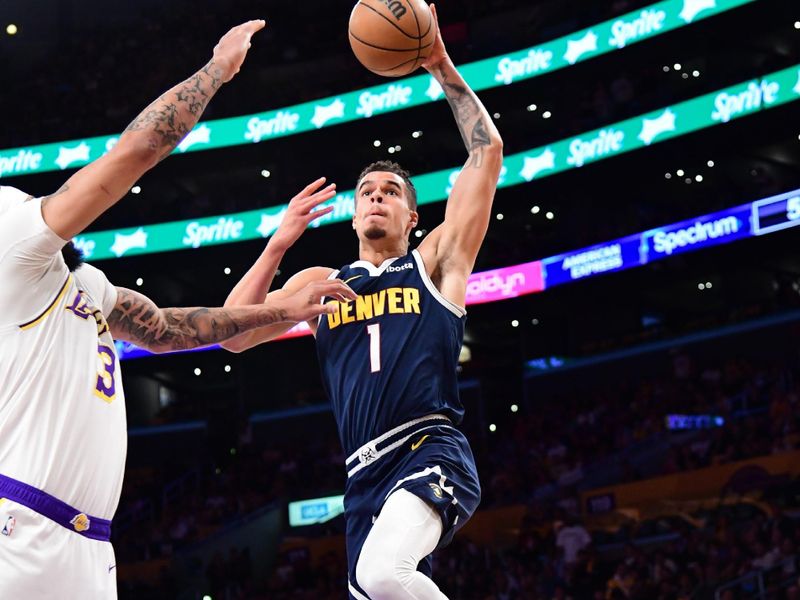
top-left (356, 490), bottom-right (447, 600)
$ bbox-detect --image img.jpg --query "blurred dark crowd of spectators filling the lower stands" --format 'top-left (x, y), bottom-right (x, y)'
top-left (116, 340), bottom-right (800, 600)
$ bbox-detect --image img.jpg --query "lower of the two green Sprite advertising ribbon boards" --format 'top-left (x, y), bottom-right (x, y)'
top-left (70, 65), bottom-right (800, 262)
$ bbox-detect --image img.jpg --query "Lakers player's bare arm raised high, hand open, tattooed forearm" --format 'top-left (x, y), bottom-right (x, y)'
top-left (42, 20), bottom-right (265, 240)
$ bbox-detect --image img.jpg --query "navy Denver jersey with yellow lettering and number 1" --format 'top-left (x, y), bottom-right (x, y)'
top-left (317, 250), bottom-right (466, 454)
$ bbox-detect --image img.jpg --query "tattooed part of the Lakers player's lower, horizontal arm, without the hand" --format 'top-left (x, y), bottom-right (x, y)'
top-left (108, 288), bottom-right (286, 351)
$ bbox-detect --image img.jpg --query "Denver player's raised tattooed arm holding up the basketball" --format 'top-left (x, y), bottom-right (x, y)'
top-left (419, 5), bottom-right (503, 306)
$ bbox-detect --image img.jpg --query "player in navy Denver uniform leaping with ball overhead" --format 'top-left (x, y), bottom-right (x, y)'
top-left (223, 6), bottom-right (503, 600)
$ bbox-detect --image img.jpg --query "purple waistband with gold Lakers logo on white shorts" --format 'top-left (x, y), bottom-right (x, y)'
top-left (0, 475), bottom-right (111, 542)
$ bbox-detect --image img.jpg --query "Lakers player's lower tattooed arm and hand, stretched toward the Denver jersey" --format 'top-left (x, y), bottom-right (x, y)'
top-left (108, 279), bottom-right (355, 353)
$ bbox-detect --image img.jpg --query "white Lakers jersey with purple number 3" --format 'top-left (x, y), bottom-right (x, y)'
top-left (0, 186), bottom-right (127, 519)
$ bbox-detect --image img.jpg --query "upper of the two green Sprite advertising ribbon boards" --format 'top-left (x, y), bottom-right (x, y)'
top-left (0, 0), bottom-right (755, 179)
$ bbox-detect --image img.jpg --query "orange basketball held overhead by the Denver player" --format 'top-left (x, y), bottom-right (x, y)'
top-left (348, 0), bottom-right (436, 77)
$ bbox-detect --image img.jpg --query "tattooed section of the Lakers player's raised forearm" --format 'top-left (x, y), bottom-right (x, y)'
top-left (125, 60), bottom-right (222, 158)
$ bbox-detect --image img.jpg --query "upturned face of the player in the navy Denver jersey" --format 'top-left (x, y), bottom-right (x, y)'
top-left (353, 171), bottom-right (418, 241)
